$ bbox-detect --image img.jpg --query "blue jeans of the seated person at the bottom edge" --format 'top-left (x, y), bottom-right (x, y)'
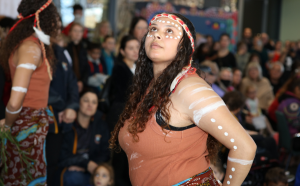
top-left (64, 170), bottom-right (91, 186)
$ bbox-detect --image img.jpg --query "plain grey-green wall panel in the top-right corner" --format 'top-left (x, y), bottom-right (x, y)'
top-left (280, 0), bottom-right (300, 41)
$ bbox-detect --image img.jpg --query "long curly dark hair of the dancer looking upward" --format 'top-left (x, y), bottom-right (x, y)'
top-left (110, 13), bottom-right (219, 160)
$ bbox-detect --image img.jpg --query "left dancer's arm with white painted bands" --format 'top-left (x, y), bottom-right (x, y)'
top-left (5, 41), bottom-right (42, 126)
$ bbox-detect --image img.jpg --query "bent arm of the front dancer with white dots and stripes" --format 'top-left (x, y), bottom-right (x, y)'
top-left (173, 77), bottom-right (256, 186)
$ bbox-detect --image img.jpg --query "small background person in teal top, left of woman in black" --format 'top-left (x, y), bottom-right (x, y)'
top-left (100, 36), bottom-right (116, 75)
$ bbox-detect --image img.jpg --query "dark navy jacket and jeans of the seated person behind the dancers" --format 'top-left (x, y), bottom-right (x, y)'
top-left (59, 111), bottom-right (110, 185)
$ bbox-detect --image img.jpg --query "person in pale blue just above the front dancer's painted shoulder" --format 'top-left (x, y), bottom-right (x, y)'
top-left (199, 60), bottom-right (225, 97)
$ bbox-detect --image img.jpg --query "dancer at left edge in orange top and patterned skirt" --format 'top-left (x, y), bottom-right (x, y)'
top-left (0, 0), bottom-right (58, 185)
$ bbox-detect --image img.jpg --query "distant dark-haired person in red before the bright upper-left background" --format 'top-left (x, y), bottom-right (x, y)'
top-left (62, 4), bottom-right (88, 39)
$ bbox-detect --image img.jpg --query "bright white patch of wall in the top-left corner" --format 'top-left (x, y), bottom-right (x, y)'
top-left (0, 0), bottom-right (21, 18)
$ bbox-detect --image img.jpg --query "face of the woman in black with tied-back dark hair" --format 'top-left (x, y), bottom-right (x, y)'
top-left (120, 39), bottom-right (140, 61)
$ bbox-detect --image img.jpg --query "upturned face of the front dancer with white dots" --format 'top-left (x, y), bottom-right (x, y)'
top-left (145, 18), bottom-right (184, 64)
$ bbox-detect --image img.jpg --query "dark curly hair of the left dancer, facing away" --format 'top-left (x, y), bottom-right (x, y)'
top-left (0, 0), bottom-right (59, 72)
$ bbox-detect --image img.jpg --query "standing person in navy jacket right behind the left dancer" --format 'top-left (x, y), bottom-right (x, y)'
top-left (46, 22), bottom-right (79, 186)
